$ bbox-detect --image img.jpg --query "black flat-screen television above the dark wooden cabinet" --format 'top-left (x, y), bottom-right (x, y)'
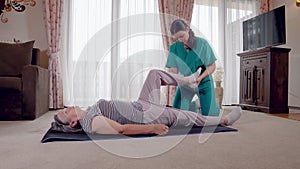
top-left (243, 5), bottom-right (286, 51)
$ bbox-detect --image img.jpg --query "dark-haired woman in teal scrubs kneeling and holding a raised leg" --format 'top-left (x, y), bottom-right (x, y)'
top-left (166, 19), bottom-right (220, 116)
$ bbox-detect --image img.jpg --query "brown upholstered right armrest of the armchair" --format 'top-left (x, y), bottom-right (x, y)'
top-left (22, 65), bottom-right (50, 119)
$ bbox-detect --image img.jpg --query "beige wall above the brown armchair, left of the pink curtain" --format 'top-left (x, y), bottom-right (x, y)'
top-left (0, 0), bottom-right (48, 67)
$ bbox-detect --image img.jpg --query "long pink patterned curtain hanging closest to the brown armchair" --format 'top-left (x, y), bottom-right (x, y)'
top-left (43, 0), bottom-right (64, 109)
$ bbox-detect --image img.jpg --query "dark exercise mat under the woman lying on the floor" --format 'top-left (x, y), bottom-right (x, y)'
top-left (41, 125), bottom-right (238, 143)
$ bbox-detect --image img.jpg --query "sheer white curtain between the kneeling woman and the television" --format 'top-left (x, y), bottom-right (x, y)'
top-left (191, 0), bottom-right (260, 105)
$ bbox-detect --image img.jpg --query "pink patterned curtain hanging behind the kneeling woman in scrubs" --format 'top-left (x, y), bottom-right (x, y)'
top-left (158, 0), bottom-right (194, 106)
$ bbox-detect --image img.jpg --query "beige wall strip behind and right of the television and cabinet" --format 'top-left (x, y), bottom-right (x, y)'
top-left (270, 0), bottom-right (300, 107)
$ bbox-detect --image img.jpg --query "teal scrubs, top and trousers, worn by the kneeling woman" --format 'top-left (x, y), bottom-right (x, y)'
top-left (166, 37), bottom-right (220, 116)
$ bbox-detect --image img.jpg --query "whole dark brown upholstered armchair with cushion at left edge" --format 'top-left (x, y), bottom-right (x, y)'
top-left (0, 41), bottom-right (50, 120)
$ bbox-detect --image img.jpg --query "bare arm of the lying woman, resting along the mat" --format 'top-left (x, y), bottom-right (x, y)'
top-left (92, 116), bottom-right (169, 135)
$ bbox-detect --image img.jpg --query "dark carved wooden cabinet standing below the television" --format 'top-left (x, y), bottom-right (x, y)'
top-left (238, 47), bottom-right (291, 113)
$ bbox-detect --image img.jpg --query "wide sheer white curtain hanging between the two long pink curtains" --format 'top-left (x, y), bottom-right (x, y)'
top-left (62, 0), bottom-right (166, 106)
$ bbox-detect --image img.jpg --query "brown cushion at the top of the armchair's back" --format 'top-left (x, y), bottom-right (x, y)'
top-left (0, 41), bottom-right (34, 76)
